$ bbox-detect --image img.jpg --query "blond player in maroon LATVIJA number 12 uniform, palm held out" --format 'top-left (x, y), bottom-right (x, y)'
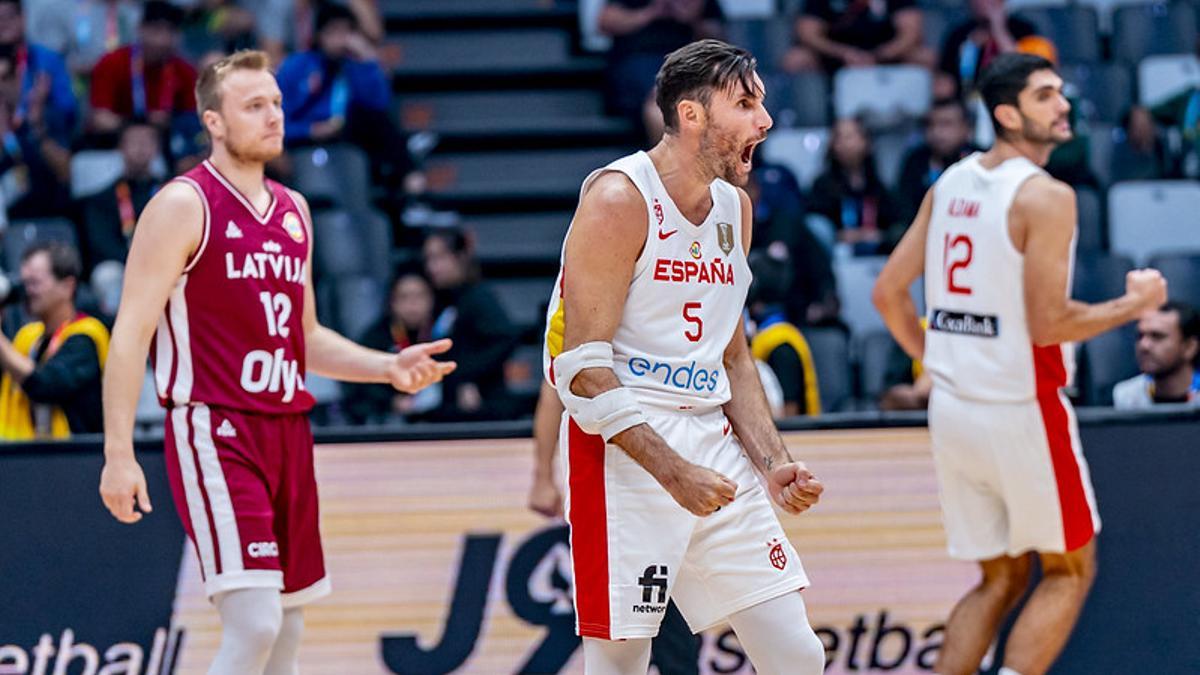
top-left (100, 52), bottom-right (455, 675)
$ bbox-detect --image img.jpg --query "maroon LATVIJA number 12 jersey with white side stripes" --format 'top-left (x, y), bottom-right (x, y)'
top-left (154, 161), bottom-right (313, 414)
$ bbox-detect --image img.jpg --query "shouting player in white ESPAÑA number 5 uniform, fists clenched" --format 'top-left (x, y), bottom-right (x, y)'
top-left (546, 40), bottom-right (824, 675)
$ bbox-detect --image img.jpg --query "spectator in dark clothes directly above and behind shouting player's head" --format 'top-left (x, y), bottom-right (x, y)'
top-left (598, 0), bottom-right (724, 140)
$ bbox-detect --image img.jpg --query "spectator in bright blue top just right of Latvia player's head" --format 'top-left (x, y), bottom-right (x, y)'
top-left (276, 5), bottom-right (412, 187)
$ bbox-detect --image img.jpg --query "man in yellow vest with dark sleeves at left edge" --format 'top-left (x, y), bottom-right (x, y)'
top-left (0, 243), bottom-right (108, 441)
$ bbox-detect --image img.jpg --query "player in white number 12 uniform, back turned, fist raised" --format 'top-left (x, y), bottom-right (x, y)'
top-left (874, 54), bottom-right (1166, 675)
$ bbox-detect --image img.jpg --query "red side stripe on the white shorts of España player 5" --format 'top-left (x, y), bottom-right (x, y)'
top-left (566, 419), bottom-right (612, 640)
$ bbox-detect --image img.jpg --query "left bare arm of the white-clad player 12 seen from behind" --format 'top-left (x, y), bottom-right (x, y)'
top-left (871, 187), bottom-right (934, 360)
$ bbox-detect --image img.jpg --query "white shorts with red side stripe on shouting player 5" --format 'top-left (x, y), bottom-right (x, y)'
top-left (559, 401), bottom-right (809, 640)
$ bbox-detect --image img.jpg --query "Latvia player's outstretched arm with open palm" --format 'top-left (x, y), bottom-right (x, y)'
top-left (290, 191), bottom-right (455, 394)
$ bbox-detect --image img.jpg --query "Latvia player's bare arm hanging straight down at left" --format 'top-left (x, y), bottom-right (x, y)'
top-left (100, 183), bottom-right (204, 522)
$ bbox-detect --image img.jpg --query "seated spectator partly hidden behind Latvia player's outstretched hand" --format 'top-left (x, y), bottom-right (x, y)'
top-left (342, 269), bottom-right (442, 424)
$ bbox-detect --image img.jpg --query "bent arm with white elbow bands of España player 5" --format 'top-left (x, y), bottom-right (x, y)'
top-left (554, 172), bottom-right (737, 515)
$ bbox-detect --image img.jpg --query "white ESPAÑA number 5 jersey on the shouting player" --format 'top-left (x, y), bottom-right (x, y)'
top-left (544, 153), bottom-right (750, 410)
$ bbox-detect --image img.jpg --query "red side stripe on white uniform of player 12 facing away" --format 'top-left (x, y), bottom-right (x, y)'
top-left (1033, 345), bottom-right (1096, 551)
